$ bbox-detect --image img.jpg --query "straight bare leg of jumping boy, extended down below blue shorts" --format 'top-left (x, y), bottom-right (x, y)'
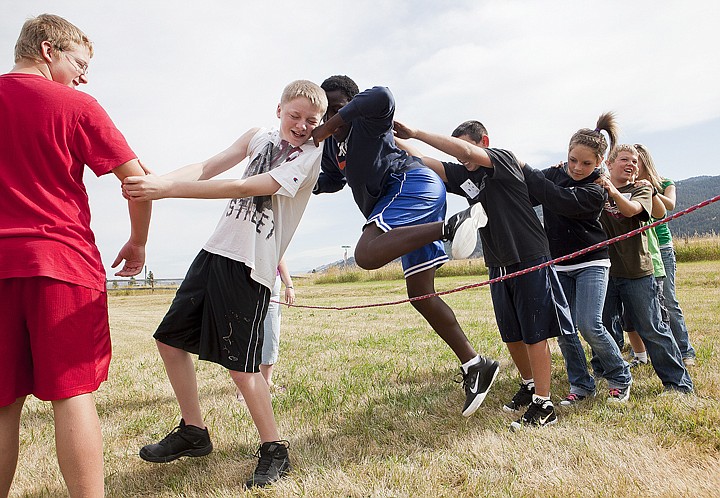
top-left (408, 268), bottom-right (477, 363)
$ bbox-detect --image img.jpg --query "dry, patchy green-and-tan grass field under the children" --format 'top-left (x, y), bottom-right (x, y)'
top-left (12, 262), bottom-right (720, 497)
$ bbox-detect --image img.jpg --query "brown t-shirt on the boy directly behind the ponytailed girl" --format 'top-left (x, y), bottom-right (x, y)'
top-left (600, 183), bottom-right (653, 278)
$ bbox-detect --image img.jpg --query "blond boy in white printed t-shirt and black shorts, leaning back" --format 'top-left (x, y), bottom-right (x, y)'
top-left (123, 80), bottom-right (327, 487)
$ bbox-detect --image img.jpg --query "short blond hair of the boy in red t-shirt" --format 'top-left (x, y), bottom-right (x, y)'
top-left (15, 14), bottom-right (93, 62)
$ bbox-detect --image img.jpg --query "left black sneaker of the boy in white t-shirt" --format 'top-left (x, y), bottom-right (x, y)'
top-left (140, 419), bottom-right (212, 463)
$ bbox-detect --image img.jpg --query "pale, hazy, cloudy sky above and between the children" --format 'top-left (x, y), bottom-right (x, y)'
top-left (0, 0), bottom-right (720, 278)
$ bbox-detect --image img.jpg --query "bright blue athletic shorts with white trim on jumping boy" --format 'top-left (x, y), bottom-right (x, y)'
top-left (366, 168), bottom-right (449, 278)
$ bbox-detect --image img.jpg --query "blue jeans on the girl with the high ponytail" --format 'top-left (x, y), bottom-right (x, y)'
top-left (557, 266), bottom-right (632, 396)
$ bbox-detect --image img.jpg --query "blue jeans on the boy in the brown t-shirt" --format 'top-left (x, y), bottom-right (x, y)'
top-left (604, 275), bottom-right (693, 392)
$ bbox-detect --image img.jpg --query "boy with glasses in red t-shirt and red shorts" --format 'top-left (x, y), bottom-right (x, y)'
top-left (0, 14), bottom-right (151, 496)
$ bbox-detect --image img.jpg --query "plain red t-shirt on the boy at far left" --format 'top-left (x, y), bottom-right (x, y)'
top-left (0, 73), bottom-right (137, 290)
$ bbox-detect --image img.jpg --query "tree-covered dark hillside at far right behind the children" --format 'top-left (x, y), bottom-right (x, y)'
top-left (669, 176), bottom-right (720, 237)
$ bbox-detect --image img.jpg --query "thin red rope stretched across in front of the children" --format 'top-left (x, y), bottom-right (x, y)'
top-left (273, 195), bottom-right (720, 311)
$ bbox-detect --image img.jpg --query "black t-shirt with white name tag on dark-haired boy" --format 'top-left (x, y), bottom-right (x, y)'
top-left (443, 148), bottom-right (550, 267)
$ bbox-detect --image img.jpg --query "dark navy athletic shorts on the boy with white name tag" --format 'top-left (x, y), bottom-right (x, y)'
top-left (488, 258), bottom-right (575, 344)
